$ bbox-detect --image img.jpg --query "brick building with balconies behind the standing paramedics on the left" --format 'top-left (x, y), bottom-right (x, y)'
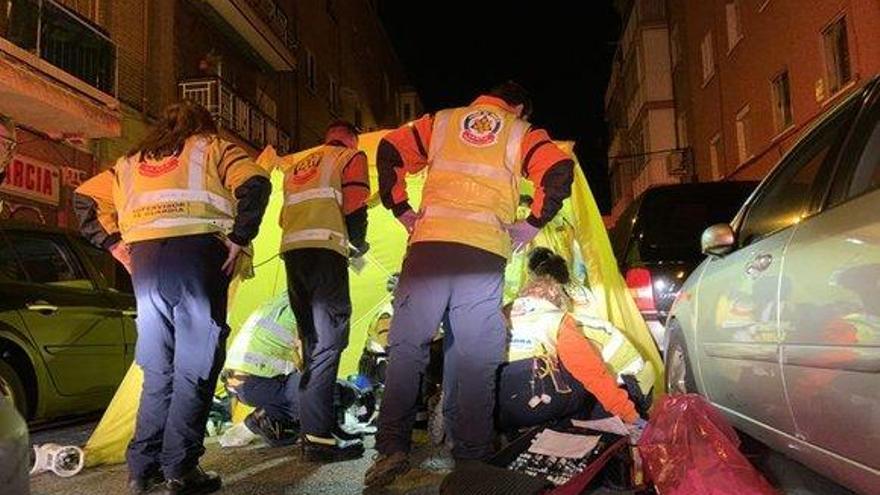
top-left (0, 0), bottom-right (421, 226)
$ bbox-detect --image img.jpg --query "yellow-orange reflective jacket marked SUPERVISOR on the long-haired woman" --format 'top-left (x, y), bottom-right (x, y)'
top-left (76, 136), bottom-right (268, 243)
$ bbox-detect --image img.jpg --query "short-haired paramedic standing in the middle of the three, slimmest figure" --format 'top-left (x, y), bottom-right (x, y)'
top-left (281, 121), bottom-right (370, 462)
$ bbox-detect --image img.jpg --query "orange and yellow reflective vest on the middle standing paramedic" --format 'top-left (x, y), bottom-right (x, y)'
top-left (280, 145), bottom-right (360, 257)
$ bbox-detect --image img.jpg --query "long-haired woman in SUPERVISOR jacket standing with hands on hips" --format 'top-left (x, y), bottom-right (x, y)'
top-left (74, 102), bottom-right (271, 494)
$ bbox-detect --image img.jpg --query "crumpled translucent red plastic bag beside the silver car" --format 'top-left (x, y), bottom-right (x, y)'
top-left (639, 394), bottom-right (777, 495)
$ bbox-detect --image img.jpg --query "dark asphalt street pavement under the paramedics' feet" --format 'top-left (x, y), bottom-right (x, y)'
top-left (31, 422), bottom-right (855, 495)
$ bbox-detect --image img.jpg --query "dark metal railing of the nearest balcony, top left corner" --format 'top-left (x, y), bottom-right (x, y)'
top-left (0, 0), bottom-right (116, 96)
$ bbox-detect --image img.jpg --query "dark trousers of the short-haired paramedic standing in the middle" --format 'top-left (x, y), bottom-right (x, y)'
top-left (282, 248), bottom-right (351, 438)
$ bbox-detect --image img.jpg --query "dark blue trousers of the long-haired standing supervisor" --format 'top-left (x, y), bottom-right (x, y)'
top-left (128, 235), bottom-right (229, 478)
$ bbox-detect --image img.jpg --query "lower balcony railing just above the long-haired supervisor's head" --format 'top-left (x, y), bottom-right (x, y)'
top-left (179, 78), bottom-right (290, 155)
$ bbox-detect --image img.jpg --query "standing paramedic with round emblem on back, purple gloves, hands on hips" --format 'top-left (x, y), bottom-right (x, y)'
top-left (365, 82), bottom-right (573, 486)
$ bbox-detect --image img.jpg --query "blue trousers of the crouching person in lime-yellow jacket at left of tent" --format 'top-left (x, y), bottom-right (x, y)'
top-left (235, 371), bottom-right (300, 421)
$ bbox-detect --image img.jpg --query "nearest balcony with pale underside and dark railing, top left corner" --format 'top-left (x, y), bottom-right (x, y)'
top-left (0, 0), bottom-right (121, 138)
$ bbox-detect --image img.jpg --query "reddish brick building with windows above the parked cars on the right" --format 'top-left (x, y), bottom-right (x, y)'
top-left (606, 0), bottom-right (880, 223)
